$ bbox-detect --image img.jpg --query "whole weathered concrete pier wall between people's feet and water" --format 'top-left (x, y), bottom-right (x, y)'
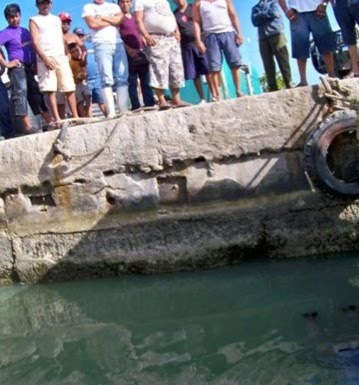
top-left (0, 80), bottom-right (359, 282)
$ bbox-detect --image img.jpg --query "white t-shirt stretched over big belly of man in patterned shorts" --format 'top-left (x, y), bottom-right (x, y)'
top-left (134, 0), bottom-right (177, 33)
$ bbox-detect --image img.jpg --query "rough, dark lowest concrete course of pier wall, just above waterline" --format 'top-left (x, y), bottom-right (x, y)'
top-left (9, 194), bottom-right (359, 282)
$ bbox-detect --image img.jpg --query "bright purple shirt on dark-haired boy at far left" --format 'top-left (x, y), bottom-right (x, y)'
top-left (0, 27), bottom-right (36, 64)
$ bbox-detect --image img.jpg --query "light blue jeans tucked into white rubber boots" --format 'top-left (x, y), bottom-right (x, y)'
top-left (94, 43), bottom-right (128, 88)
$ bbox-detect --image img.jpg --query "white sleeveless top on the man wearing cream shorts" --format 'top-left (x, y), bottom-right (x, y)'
top-left (30, 13), bottom-right (65, 57)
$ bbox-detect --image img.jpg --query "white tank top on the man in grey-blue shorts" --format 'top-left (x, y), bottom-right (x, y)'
top-left (199, 0), bottom-right (234, 33)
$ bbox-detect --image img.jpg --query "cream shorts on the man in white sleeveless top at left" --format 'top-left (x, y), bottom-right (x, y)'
top-left (37, 55), bottom-right (75, 92)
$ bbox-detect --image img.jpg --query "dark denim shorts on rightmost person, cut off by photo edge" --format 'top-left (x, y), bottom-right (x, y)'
top-left (334, 0), bottom-right (359, 45)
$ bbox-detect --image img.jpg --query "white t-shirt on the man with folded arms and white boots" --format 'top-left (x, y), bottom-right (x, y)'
top-left (81, 2), bottom-right (122, 44)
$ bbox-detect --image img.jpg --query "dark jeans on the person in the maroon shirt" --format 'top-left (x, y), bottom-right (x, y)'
top-left (128, 68), bottom-right (155, 110)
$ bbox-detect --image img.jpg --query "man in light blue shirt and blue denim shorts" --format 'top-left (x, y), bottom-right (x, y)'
top-left (279, 0), bottom-right (335, 87)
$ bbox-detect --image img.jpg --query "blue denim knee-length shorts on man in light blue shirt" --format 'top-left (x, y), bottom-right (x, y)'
top-left (290, 11), bottom-right (335, 59)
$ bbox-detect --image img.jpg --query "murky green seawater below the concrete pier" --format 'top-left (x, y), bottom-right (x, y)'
top-left (0, 254), bottom-right (359, 385)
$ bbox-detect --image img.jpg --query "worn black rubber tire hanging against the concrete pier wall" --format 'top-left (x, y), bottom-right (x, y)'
top-left (304, 110), bottom-right (359, 199)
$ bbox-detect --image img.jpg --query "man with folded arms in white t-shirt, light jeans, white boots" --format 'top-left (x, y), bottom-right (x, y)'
top-left (82, 0), bottom-right (128, 118)
